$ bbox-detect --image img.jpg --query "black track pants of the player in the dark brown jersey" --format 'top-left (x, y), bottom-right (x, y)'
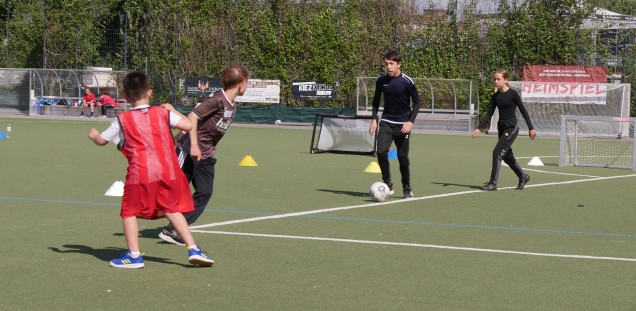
top-left (165, 151), bottom-right (216, 230)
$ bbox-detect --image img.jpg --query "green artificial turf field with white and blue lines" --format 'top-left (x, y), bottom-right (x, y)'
top-left (0, 118), bottom-right (636, 310)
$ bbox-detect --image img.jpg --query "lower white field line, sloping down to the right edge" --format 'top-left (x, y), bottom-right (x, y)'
top-left (192, 230), bottom-right (636, 262)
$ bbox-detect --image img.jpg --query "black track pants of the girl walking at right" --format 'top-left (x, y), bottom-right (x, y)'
top-left (490, 124), bottom-right (524, 185)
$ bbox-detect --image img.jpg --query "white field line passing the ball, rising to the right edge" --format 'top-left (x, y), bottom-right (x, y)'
top-left (190, 174), bottom-right (636, 230)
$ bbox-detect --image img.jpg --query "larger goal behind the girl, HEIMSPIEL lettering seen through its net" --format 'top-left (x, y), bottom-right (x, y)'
top-left (490, 81), bottom-right (631, 136)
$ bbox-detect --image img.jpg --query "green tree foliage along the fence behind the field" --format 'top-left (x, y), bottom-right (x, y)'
top-left (0, 0), bottom-right (636, 116)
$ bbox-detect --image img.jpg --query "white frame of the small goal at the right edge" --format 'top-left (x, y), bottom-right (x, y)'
top-left (559, 115), bottom-right (636, 171)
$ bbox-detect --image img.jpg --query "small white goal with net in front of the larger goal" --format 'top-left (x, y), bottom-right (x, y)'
top-left (559, 115), bottom-right (636, 170)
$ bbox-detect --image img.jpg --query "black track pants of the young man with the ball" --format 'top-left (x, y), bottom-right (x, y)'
top-left (377, 121), bottom-right (411, 189)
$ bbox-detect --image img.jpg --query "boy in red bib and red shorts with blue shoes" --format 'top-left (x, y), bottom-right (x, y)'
top-left (88, 72), bottom-right (214, 268)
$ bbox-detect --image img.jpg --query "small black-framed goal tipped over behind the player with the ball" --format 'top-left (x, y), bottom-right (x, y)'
top-left (310, 114), bottom-right (377, 154)
